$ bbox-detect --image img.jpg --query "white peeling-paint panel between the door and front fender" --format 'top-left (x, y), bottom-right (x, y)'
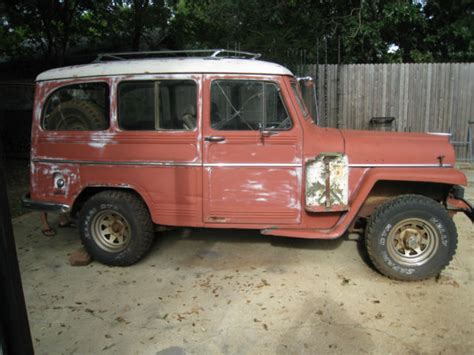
top-left (305, 153), bottom-right (349, 210)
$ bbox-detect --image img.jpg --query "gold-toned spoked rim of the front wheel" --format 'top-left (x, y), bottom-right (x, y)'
top-left (387, 218), bottom-right (439, 266)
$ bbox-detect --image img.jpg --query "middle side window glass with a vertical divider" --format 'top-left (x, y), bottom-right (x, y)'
top-left (118, 80), bottom-right (197, 131)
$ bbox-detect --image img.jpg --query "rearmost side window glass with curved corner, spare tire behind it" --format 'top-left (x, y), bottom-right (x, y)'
top-left (42, 83), bottom-right (109, 131)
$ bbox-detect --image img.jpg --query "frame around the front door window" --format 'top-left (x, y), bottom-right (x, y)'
top-left (209, 77), bottom-right (295, 132)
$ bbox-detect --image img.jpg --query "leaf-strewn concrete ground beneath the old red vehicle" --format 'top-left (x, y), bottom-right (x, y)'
top-left (14, 171), bottom-right (474, 355)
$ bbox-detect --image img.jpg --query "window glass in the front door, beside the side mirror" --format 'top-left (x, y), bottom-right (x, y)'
top-left (211, 80), bottom-right (292, 131)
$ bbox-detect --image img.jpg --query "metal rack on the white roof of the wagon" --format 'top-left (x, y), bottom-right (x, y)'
top-left (94, 49), bottom-right (262, 62)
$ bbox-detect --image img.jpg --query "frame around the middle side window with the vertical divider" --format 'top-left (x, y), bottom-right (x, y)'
top-left (115, 77), bottom-right (200, 133)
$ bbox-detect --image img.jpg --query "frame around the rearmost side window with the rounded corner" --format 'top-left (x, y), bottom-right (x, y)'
top-left (39, 80), bottom-right (112, 133)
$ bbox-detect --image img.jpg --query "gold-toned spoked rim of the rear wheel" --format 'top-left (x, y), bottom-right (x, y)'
top-left (91, 210), bottom-right (131, 253)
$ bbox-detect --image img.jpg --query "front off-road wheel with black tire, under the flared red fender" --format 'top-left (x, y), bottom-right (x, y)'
top-left (365, 195), bottom-right (457, 281)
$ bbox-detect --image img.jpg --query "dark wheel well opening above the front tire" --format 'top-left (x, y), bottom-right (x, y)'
top-left (357, 180), bottom-right (452, 218)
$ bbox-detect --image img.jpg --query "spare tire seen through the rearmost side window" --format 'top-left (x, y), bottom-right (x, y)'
top-left (46, 100), bottom-right (108, 131)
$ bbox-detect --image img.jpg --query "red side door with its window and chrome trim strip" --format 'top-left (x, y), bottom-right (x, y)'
top-left (203, 75), bottom-right (302, 228)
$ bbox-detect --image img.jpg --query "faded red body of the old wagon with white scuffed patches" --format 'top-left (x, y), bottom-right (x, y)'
top-left (25, 53), bottom-right (471, 280)
